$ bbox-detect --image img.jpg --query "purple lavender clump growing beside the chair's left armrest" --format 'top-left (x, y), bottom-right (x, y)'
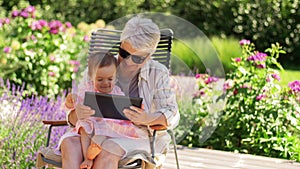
top-left (0, 80), bottom-right (66, 168)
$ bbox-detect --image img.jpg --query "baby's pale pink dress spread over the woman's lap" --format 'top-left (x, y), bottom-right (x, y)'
top-left (55, 79), bottom-right (148, 155)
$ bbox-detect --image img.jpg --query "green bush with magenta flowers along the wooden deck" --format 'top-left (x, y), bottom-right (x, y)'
top-left (187, 40), bottom-right (300, 161)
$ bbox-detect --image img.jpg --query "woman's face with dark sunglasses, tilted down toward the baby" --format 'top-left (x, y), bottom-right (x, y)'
top-left (119, 41), bottom-right (150, 72)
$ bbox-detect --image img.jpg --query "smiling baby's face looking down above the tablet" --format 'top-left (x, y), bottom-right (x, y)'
top-left (93, 64), bottom-right (117, 93)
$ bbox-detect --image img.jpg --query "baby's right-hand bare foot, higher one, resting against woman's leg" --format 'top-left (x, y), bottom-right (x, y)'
top-left (87, 135), bottom-right (106, 160)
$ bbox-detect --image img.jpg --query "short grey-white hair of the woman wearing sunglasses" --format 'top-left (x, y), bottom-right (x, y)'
top-left (120, 16), bottom-right (160, 55)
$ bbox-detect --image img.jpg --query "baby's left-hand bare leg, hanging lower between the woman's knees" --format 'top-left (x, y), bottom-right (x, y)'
top-left (79, 127), bottom-right (93, 168)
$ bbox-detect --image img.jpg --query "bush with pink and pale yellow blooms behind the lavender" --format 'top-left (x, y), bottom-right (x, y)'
top-left (0, 6), bottom-right (88, 96)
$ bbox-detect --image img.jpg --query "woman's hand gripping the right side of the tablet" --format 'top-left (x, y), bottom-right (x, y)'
top-left (123, 106), bottom-right (161, 125)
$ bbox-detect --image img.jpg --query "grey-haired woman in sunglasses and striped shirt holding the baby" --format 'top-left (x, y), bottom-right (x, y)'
top-left (60, 16), bottom-right (180, 169)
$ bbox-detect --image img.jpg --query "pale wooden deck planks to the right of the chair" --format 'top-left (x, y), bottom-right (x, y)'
top-left (162, 146), bottom-right (300, 169)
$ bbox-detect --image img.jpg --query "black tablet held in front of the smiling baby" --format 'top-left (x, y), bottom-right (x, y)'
top-left (83, 92), bottom-right (143, 120)
